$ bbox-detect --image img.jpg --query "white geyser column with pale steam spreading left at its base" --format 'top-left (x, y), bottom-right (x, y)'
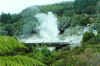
top-left (21, 12), bottom-right (59, 43)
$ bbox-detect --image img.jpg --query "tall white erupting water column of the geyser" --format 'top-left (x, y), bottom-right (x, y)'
top-left (36, 12), bottom-right (59, 42)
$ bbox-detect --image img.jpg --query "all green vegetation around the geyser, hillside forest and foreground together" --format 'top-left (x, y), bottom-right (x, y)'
top-left (0, 0), bottom-right (100, 66)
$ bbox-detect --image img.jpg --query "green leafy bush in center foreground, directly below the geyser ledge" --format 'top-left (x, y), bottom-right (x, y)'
top-left (31, 46), bottom-right (58, 65)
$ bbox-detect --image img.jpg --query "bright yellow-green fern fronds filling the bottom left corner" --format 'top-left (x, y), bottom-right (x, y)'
top-left (0, 56), bottom-right (46, 66)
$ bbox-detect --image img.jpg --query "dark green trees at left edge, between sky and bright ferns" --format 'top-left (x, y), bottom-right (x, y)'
top-left (0, 13), bottom-right (23, 36)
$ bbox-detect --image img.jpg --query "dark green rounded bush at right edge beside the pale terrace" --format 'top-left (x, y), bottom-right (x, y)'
top-left (82, 32), bottom-right (100, 47)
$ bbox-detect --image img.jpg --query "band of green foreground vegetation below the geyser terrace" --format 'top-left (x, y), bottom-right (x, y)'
top-left (0, 35), bottom-right (100, 66)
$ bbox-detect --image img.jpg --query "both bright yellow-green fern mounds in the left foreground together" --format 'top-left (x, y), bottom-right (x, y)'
top-left (0, 36), bottom-right (45, 66)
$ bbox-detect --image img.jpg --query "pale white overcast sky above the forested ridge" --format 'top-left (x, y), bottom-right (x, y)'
top-left (0, 0), bottom-right (73, 14)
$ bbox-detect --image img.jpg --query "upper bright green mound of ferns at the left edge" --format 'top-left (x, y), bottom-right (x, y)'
top-left (0, 36), bottom-right (26, 55)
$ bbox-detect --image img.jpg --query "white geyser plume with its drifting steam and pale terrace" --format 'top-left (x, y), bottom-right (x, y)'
top-left (20, 12), bottom-right (97, 46)
